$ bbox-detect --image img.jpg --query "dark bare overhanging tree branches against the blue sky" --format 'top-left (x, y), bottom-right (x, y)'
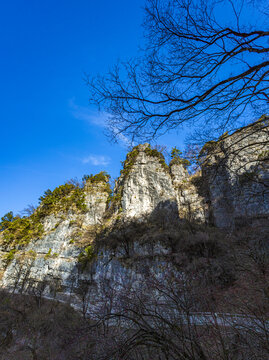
top-left (88, 0), bottom-right (269, 143)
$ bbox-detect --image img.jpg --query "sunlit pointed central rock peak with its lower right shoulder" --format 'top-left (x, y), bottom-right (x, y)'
top-left (111, 144), bottom-right (206, 221)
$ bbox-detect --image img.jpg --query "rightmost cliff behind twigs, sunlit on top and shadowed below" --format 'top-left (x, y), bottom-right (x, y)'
top-left (202, 119), bottom-right (269, 227)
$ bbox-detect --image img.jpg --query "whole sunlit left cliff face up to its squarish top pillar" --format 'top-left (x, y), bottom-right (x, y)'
top-left (0, 183), bottom-right (108, 300)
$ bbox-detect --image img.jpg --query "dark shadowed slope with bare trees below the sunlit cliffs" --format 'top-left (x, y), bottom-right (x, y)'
top-left (0, 210), bottom-right (269, 360)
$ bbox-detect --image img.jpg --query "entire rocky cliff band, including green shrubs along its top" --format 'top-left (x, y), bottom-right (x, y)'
top-left (0, 121), bottom-right (269, 304)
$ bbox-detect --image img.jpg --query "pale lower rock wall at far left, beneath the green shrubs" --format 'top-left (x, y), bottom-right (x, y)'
top-left (2, 217), bottom-right (80, 293)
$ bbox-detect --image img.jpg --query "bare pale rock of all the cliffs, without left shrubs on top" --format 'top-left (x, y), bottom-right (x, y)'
top-left (0, 121), bottom-right (269, 304)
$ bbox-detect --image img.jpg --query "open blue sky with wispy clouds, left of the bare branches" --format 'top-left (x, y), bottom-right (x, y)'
top-left (0, 0), bottom-right (185, 216)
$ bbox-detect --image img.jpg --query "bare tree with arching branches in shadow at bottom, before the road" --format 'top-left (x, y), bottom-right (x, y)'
top-left (90, 262), bottom-right (269, 360)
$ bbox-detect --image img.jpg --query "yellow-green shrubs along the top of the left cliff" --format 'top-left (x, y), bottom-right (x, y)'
top-left (0, 171), bottom-right (111, 253)
